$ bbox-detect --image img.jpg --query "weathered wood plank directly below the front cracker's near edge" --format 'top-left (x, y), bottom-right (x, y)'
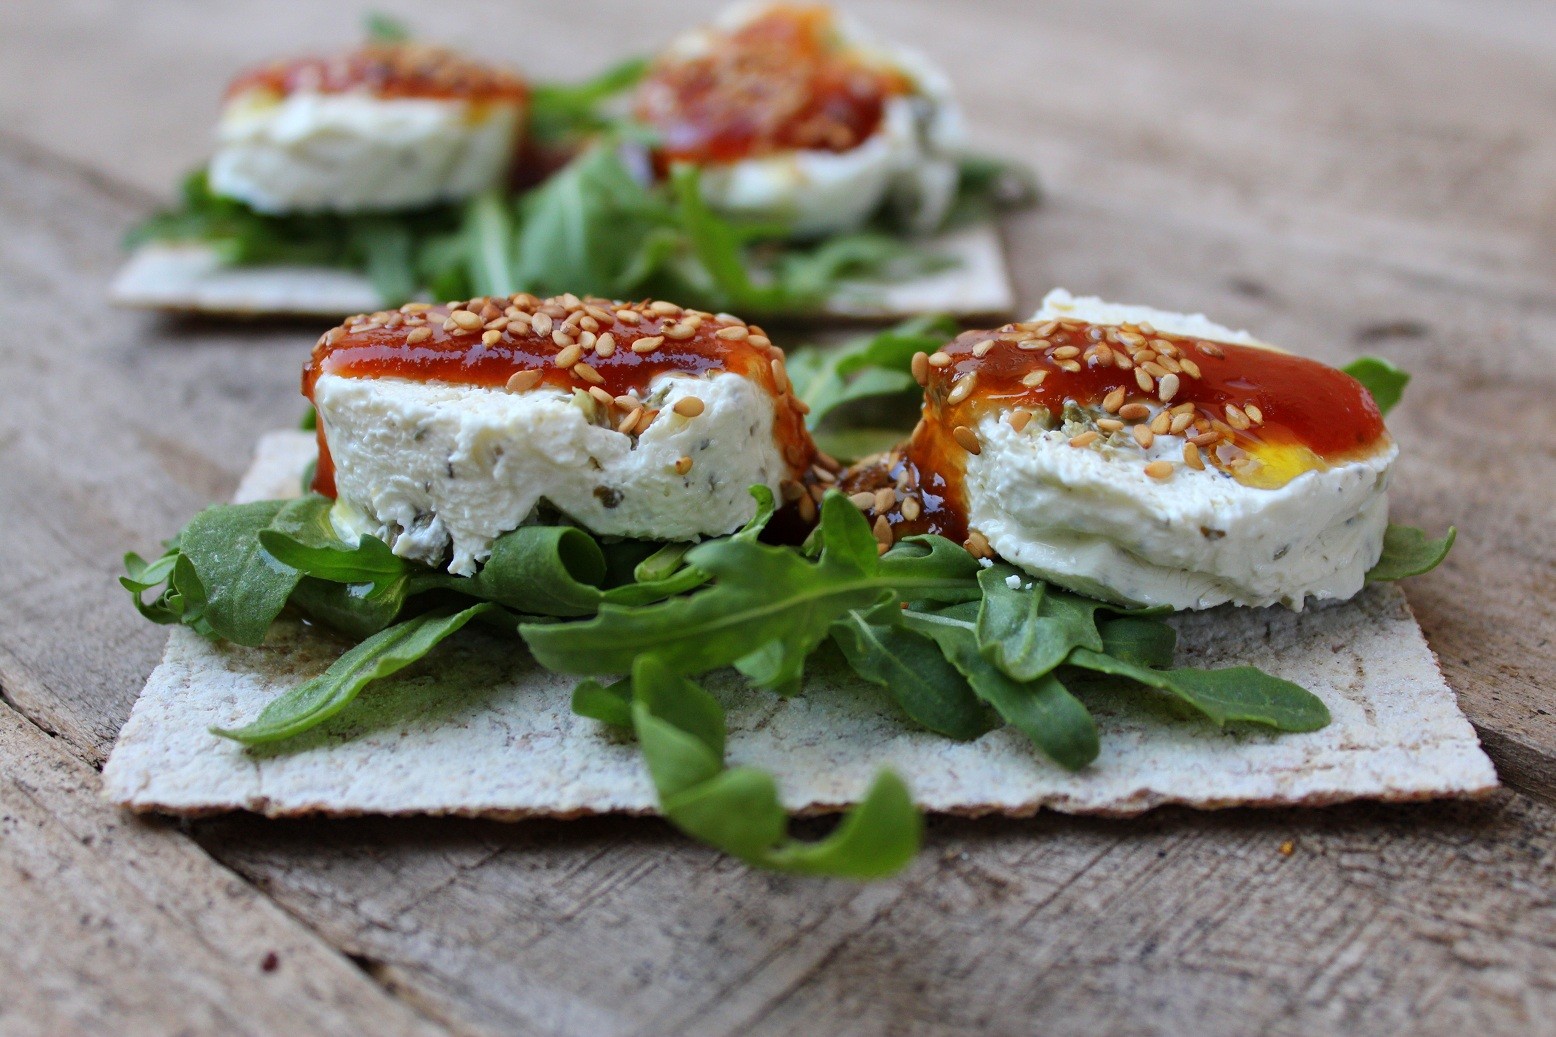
top-left (196, 796), bottom-right (1556, 1034)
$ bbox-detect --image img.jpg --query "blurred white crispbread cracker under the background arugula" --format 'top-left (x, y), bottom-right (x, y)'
top-left (109, 223), bottom-right (1016, 321)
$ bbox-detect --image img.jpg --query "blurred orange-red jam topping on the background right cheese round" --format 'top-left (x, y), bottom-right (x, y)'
top-left (636, 5), bottom-right (912, 163)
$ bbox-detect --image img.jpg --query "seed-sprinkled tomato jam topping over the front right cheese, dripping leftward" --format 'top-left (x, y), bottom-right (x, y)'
top-left (840, 319), bottom-right (1386, 554)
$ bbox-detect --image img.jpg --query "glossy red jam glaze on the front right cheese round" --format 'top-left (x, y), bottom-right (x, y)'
top-left (840, 321), bottom-right (1386, 542)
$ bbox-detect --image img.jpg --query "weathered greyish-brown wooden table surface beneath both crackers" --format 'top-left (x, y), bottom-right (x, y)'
top-left (0, 0), bottom-right (1556, 1037)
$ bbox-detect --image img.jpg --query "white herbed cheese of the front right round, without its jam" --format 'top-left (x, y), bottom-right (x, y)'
top-left (965, 290), bottom-right (1399, 609)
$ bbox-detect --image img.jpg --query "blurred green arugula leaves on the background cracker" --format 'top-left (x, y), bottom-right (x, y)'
top-left (128, 34), bottom-right (1036, 318)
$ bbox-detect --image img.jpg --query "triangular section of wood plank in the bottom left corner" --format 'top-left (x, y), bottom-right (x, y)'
top-left (0, 704), bottom-right (440, 1037)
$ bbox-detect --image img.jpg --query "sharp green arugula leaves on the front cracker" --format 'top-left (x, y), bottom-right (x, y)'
top-left (121, 326), bottom-right (1453, 878)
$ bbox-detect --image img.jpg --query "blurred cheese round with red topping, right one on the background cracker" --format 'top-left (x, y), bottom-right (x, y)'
top-left (636, 3), bottom-right (962, 237)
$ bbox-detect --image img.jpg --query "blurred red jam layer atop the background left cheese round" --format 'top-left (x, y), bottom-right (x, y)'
top-left (227, 44), bottom-right (529, 103)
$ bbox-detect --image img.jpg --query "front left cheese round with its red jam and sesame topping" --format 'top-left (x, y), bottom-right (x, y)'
top-left (305, 296), bottom-right (814, 575)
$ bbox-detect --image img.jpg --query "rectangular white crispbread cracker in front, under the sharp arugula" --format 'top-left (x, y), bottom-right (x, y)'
top-left (103, 433), bottom-right (1497, 817)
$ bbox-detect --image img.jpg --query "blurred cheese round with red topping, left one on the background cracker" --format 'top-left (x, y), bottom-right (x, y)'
top-left (209, 44), bottom-right (526, 213)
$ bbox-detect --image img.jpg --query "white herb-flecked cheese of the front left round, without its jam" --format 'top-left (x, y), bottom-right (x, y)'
top-left (314, 372), bottom-right (789, 575)
